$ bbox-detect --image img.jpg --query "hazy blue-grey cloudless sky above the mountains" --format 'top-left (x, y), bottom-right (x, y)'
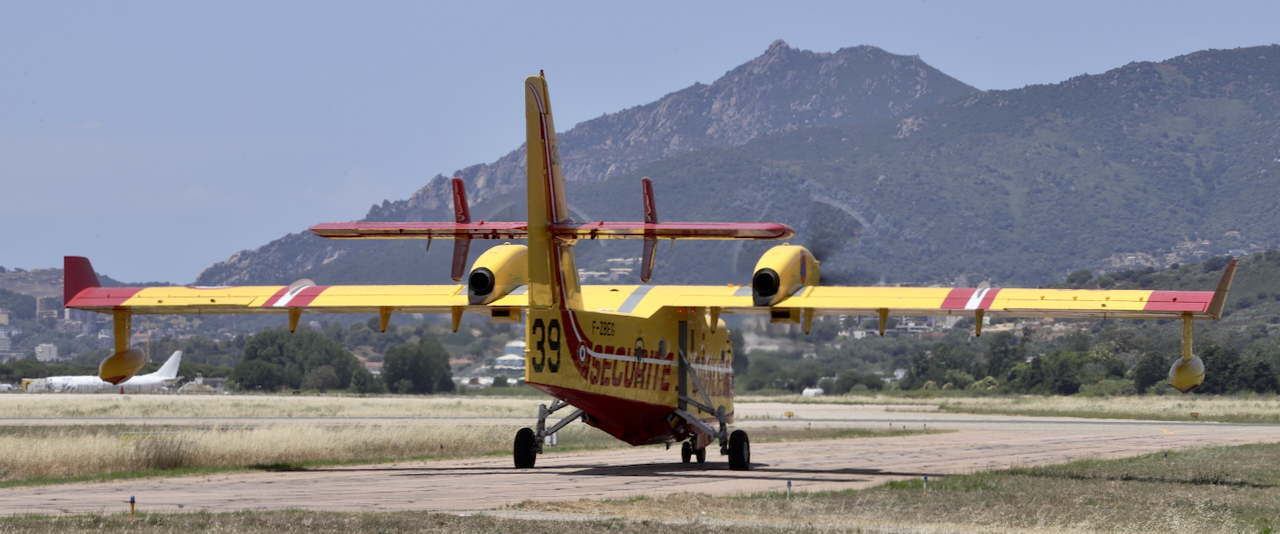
top-left (0, 0), bottom-right (1280, 283)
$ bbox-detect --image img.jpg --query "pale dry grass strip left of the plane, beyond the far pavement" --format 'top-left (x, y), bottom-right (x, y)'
top-left (0, 393), bottom-right (549, 417)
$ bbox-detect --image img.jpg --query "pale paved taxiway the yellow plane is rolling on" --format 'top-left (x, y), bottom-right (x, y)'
top-left (0, 403), bottom-right (1280, 514)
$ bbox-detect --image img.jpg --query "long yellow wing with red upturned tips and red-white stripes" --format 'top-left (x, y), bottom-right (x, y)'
top-left (67, 257), bottom-right (1234, 319)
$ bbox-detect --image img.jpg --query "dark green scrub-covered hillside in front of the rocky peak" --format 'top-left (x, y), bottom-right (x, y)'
top-left (192, 46), bottom-right (1280, 286)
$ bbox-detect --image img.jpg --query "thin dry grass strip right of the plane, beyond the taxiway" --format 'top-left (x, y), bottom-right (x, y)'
top-left (737, 394), bottom-right (1280, 424)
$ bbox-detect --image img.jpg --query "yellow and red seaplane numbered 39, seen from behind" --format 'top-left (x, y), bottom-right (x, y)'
top-left (65, 76), bottom-right (1235, 470)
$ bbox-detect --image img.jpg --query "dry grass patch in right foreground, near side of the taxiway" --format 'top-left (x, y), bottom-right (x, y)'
top-left (518, 444), bottom-right (1280, 534)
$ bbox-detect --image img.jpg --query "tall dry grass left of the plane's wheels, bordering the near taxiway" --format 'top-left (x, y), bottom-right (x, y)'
top-left (0, 421), bottom-right (623, 483)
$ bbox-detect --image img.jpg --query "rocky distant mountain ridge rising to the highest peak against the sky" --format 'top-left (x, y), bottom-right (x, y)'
top-left (196, 40), bottom-right (975, 284)
